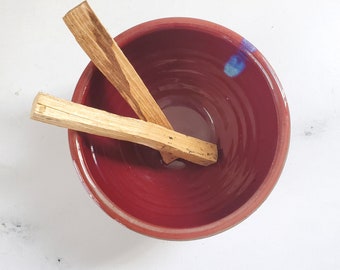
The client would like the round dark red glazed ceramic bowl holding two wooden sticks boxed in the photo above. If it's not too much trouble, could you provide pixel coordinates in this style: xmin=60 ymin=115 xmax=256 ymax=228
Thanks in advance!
xmin=69 ymin=18 xmax=290 ymax=240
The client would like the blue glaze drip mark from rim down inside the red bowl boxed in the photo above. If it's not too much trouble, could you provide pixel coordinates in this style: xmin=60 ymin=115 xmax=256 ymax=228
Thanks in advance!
xmin=224 ymin=39 xmax=256 ymax=78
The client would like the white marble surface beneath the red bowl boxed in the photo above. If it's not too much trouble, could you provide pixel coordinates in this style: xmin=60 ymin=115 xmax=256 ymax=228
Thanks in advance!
xmin=0 ymin=0 xmax=340 ymax=270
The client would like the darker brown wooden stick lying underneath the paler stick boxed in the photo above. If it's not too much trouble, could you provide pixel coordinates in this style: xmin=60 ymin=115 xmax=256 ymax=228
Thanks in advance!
xmin=64 ymin=1 xmax=176 ymax=163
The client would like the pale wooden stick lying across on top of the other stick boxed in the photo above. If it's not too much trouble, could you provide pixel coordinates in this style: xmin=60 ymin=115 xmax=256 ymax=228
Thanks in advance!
xmin=31 ymin=93 xmax=217 ymax=166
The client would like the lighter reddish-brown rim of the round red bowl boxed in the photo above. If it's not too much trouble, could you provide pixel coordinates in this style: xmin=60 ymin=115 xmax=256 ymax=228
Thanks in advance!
xmin=68 ymin=17 xmax=290 ymax=240
